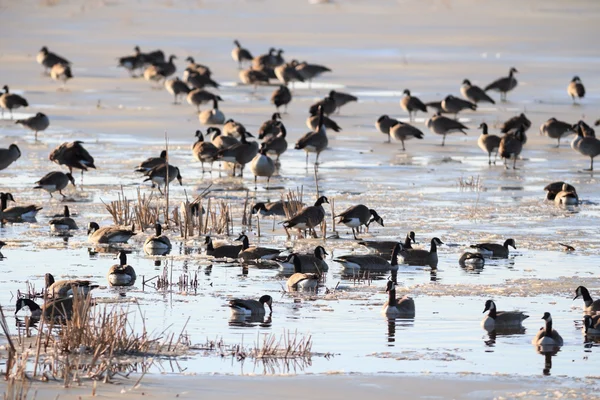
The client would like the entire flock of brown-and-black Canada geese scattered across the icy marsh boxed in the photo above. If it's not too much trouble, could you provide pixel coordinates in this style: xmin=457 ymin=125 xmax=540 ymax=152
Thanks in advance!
xmin=0 ymin=40 xmax=600 ymax=346
